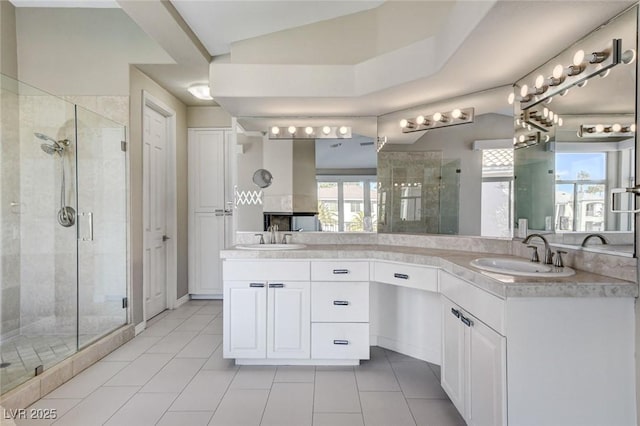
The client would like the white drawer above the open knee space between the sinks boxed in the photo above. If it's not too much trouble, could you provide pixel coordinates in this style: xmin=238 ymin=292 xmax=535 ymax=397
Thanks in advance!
xmin=373 ymin=261 xmax=438 ymax=292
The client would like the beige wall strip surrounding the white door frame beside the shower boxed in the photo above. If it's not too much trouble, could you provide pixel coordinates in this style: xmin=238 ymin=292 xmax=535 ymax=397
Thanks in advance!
xmin=129 ymin=66 xmax=188 ymax=324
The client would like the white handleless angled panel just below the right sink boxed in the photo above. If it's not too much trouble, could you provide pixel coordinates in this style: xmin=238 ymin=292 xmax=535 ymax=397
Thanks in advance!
xmin=440 ymin=271 xmax=505 ymax=336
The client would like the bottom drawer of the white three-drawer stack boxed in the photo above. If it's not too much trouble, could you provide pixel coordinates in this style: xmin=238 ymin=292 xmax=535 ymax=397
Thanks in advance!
xmin=311 ymin=323 xmax=369 ymax=359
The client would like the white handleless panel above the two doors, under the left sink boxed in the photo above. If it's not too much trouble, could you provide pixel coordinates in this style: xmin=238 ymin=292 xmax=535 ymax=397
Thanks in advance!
xmin=222 ymin=260 xmax=310 ymax=281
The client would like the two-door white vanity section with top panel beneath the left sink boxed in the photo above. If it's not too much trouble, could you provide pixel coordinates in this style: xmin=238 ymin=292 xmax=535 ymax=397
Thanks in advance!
xmin=223 ymin=261 xmax=311 ymax=363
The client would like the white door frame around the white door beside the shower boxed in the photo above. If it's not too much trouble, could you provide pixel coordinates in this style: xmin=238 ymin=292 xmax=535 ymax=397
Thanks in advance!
xmin=141 ymin=90 xmax=178 ymax=327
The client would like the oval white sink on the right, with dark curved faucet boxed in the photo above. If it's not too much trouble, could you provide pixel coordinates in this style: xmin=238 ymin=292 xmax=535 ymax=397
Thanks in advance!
xmin=470 ymin=257 xmax=576 ymax=277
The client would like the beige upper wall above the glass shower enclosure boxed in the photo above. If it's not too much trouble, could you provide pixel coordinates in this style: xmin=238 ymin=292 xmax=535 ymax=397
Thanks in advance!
xmin=16 ymin=7 xmax=173 ymax=96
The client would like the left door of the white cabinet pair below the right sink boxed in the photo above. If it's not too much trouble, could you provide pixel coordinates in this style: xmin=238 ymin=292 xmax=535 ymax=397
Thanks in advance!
xmin=440 ymin=297 xmax=466 ymax=416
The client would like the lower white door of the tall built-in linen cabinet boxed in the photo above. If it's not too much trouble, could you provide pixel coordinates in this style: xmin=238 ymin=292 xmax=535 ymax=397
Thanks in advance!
xmin=189 ymin=213 xmax=224 ymax=295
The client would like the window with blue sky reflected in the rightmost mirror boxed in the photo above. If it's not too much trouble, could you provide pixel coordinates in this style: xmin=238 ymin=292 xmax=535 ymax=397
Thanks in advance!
xmin=555 ymin=152 xmax=607 ymax=232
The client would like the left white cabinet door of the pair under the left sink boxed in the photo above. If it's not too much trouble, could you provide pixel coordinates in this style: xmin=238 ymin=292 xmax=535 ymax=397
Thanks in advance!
xmin=223 ymin=281 xmax=267 ymax=358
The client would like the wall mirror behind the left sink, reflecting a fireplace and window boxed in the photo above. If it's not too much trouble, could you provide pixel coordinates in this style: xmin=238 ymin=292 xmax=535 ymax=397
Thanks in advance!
xmin=235 ymin=117 xmax=378 ymax=232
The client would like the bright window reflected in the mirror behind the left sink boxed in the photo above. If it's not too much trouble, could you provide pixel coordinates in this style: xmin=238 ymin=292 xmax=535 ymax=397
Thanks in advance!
xmin=318 ymin=176 xmax=378 ymax=232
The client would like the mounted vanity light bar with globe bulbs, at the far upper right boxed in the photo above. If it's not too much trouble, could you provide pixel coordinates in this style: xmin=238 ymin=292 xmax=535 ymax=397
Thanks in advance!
xmin=508 ymin=38 xmax=624 ymax=110
